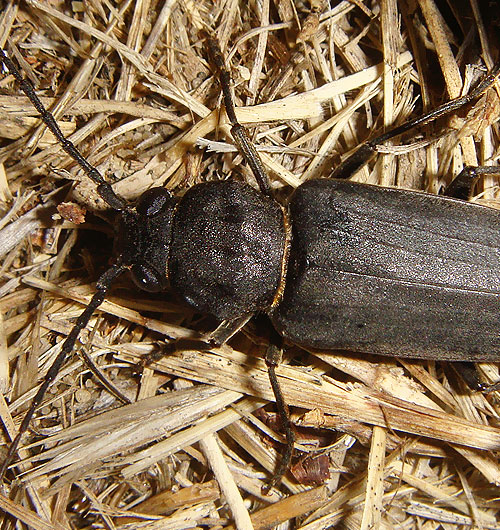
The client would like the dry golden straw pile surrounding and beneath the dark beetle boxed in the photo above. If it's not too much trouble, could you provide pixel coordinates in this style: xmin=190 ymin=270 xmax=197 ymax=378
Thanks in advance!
xmin=0 ymin=0 xmax=500 ymax=529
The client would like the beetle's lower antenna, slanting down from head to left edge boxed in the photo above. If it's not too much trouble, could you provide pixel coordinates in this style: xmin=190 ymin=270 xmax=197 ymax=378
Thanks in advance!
xmin=0 ymin=263 xmax=126 ymax=481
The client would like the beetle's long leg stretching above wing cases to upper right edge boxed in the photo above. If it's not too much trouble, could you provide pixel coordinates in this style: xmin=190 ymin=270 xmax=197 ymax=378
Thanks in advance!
xmin=330 ymin=62 xmax=500 ymax=179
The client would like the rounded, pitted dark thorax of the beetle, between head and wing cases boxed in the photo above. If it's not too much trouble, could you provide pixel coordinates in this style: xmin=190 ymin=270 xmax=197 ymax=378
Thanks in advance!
xmin=168 ymin=180 xmax=286 ymax=320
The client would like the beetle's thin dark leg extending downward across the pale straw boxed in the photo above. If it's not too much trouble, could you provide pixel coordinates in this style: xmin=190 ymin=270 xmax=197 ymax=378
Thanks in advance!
xmin=262 ymin=343 xmax=295 ymax=495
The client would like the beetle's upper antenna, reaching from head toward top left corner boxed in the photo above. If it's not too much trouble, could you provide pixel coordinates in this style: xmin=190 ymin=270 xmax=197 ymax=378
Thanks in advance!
xmin=0 ymin=48 xmax=127 ymax=211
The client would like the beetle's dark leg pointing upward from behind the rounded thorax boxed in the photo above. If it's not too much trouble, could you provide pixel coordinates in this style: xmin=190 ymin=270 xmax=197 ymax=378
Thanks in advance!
xmin=208 ymin=37 xmax=272 ymax=197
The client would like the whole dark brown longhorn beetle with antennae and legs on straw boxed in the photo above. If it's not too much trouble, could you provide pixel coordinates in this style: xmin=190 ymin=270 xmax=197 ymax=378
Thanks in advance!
xmin=0 ymin=37 xmax=500 ymax=490
